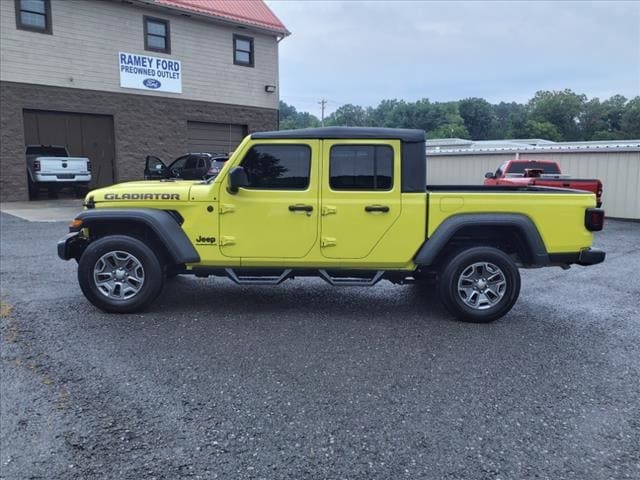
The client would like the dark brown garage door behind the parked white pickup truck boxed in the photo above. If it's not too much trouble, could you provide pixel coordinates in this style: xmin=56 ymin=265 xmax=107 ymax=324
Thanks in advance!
xmin=24 ymin=110 xmax=115 ymax=188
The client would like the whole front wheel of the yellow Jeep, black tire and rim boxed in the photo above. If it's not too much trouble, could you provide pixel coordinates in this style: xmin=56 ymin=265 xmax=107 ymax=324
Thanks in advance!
xmin=78 ymin=235 xmax=164 ymax=313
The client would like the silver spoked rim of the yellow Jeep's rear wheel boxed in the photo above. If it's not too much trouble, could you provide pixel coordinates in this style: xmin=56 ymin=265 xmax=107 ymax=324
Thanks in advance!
xmin=458 ymin=262 xmax=507 ymax=310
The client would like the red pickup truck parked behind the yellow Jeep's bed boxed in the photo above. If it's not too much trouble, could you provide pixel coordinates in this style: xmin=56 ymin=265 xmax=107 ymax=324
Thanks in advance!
xmin=484 ymin=160 xmax=602 ymax=207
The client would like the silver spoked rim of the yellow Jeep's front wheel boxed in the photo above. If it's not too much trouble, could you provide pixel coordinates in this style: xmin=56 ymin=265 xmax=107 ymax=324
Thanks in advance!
xmin=93 ymin=250 xmax=144 ymax=300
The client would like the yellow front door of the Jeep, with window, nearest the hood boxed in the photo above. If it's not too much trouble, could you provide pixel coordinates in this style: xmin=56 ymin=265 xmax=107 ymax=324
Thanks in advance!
xmin=219 ymin=140 xmax=320 ymax=256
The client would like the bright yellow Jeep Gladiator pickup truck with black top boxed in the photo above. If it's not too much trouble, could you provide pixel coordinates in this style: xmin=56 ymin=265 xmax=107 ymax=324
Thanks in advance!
xmin=58 ymin=127 xmax=605 ymax=322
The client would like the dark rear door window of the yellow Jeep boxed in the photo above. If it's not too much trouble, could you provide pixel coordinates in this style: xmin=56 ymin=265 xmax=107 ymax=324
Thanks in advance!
xmin=329 ymin=145 xmax=393 ymax=190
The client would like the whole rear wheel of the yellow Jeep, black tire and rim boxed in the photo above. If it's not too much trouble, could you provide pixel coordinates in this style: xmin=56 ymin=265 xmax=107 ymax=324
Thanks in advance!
xmin=439 ymin=247 xmax=520 ymax=323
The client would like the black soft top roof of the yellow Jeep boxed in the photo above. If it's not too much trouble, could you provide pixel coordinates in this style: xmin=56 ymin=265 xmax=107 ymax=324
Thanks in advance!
xmin=251 ymin=127 xmax=425 ymax=143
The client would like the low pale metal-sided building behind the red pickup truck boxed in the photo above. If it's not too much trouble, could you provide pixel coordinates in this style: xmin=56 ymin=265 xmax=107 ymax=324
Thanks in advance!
xmin=427 ymin=138 xmax=640 ymax=220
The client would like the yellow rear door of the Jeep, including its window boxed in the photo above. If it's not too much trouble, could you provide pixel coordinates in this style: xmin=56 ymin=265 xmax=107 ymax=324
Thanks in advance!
xmin=320 ymin=140 xmax=402 ymax=259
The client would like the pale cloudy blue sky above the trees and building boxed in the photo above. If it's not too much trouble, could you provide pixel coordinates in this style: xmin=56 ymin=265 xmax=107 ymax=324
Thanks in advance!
xmin=267 ymin=0 xmax=640 ymax=116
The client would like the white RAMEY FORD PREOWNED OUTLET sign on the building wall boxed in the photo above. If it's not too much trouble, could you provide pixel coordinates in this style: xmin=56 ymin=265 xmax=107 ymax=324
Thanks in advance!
xmin=118 ymin=52 xmax=182 ymax=93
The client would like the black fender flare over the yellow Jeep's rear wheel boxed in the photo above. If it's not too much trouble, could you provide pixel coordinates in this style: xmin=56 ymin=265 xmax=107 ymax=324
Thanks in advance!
xmin=414 ymin=213 xmax=549 ymax=266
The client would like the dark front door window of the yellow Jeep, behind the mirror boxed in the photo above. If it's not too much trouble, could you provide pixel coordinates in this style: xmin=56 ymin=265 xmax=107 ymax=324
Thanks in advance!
xmin=241 ymin=145 xmax=311 ymax=190
